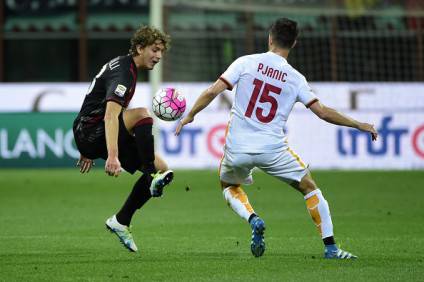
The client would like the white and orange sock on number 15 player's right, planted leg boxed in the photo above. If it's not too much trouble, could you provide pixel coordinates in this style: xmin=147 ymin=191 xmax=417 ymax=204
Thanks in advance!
xmin=304 ymin=189 xmax=333 ymax=239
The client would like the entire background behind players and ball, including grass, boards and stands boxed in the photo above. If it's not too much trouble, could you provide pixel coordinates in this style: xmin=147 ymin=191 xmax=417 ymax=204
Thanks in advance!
xmin=0 ymin=0 xmax=424 ymax=281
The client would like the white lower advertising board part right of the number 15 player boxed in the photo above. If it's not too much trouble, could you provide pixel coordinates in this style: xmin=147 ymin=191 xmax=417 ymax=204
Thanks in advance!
xmin=288 ymin=112 xmax=424 ymax=169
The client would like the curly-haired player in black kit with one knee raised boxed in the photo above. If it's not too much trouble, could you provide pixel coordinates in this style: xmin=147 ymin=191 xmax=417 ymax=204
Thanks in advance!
xmin=73 ymin=26 xmax=173 ymax=252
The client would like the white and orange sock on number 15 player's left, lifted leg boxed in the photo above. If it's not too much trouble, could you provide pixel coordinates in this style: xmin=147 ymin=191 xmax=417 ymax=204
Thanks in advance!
xmin=223 ymin=186 xmax=255 ymax=221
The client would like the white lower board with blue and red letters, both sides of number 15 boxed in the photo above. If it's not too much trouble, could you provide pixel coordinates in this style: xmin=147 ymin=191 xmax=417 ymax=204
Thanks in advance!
xmin=158 ymin=110 xmax=424 ymax=169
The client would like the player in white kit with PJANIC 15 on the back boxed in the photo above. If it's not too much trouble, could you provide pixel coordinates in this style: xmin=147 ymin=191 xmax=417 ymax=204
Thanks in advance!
xmin=175 ymin=18 xmax=377 ymax=259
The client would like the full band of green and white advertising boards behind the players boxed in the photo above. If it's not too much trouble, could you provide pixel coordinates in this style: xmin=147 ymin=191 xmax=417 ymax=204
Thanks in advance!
xmin=0 ymin=83 xmax=424 ymax=169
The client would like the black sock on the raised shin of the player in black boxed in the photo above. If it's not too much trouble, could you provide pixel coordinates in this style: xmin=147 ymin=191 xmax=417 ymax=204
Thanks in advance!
xmin=134 ymin=117 xmax=156 ymax=174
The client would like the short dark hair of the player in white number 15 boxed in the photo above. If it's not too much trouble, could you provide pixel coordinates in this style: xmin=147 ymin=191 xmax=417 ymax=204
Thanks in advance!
xmin=269 ymin=18 xmax=299 ymax=49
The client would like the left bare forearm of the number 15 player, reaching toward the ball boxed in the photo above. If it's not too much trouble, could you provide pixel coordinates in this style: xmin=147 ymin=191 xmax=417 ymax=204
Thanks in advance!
xmin=175 ymin=79 xmax=228 ymax=136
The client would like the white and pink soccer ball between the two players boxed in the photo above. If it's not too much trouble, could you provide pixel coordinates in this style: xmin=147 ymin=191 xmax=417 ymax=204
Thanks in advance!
xmin=152 ymin=88 xmax=186 ymax=121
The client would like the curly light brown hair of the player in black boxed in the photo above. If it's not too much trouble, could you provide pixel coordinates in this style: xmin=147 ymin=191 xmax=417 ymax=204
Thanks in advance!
xmin=129 ymin=25 xmax=171 ymax=56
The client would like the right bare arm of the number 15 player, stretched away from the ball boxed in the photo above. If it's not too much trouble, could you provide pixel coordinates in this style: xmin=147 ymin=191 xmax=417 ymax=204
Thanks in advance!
xmin=309 ymin=101 xmax=378 ymax=141
